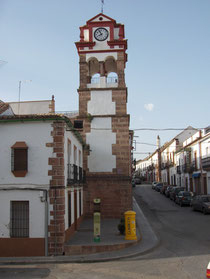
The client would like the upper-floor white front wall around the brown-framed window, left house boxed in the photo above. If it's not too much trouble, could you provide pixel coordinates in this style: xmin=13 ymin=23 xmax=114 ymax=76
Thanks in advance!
xmin=0 ymin=121 xmax=52 ymax=187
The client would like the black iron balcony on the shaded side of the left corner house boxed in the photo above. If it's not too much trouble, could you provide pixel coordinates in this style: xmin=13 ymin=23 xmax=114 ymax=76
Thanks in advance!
xmin=67 ymin=164 xmax=86 ymax=185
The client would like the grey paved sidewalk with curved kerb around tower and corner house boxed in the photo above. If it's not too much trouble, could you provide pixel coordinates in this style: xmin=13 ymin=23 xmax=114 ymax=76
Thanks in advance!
xmin=0 ymin=199 xmax=159 ymax=264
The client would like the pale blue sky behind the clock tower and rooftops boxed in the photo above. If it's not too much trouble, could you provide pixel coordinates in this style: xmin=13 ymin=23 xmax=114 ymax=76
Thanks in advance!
xmin=0 ymin=0 xmax=210 ymax=159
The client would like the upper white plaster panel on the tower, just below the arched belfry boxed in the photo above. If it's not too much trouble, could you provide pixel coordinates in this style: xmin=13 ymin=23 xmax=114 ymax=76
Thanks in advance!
xmin=87 ymin=90 xmax=116 ymax=115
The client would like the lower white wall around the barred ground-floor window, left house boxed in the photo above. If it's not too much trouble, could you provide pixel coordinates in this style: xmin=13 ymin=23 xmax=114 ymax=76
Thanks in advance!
xmin=0 ymin=190 xmax=45 ymax=238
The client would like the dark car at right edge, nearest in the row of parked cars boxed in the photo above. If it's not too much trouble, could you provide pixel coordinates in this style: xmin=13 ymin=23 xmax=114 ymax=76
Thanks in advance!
xmin=191 ymin=195 xmax=210 ymax=214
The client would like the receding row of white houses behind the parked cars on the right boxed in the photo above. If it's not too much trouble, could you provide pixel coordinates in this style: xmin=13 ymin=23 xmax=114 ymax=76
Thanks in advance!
xmin=137 ymin=127 xmax=210 ymax=194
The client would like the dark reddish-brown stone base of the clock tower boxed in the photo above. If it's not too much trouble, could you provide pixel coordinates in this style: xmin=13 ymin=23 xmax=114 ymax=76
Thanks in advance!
xmin=84 ymin=175 xmax=132 ymax=218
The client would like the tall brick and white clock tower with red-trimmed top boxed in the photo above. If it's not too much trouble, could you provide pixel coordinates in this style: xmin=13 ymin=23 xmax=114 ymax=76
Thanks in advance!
xmin=76 ymin=13 xmax=132 ymax=218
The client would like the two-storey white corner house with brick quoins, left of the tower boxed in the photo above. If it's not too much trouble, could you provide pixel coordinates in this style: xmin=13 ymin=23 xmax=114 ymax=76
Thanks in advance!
xmin=0 ymin=114 xmax=84 ymax=257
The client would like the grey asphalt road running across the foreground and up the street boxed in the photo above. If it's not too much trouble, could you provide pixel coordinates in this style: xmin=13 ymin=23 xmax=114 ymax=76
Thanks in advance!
xmin=0 ymin=185 xmax=210 ymax=279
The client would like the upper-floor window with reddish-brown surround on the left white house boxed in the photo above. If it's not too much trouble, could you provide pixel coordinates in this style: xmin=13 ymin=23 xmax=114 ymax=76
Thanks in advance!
xmin=11 ymin=141 xmax=28 ymax=177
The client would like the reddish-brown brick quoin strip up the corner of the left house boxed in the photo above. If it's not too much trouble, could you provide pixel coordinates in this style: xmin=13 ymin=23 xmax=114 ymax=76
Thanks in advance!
xmin=46 ymin=121 xmax=66 ymax=255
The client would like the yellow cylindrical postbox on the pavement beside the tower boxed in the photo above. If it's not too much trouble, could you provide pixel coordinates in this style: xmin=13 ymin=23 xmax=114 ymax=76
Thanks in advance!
xmin=124 ymin=211 xmax=137 ymax=240
